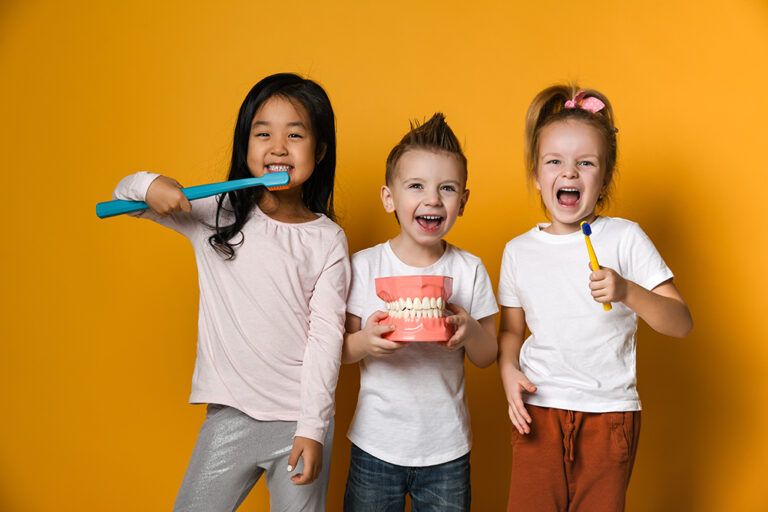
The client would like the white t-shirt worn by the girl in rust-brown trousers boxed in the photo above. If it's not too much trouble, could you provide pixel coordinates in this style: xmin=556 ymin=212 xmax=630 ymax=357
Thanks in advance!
xmin=499 ymin=217 xmax=672 ymax=412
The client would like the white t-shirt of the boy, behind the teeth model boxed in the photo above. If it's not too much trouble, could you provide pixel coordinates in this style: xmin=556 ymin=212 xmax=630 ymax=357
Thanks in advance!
xmin=347 ymin=242 xmax=498 ymax=466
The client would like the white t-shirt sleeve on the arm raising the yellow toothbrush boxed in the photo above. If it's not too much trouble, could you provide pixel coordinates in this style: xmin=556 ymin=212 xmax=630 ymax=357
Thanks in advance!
xmin=622 ymin=223 xmax=673 ymax=290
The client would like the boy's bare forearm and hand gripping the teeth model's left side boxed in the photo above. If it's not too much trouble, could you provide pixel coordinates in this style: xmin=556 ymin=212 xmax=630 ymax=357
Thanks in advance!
xmin=341 ymin=311 xmax=405 ymax=364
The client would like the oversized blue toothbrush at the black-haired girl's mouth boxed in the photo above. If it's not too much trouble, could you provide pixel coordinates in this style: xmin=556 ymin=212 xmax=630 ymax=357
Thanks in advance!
xmin=96 ymin=172 xmax=289 ymax=219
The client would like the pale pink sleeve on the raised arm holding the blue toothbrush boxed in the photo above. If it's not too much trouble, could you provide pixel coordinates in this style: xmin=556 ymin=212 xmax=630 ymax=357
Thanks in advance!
xmin=112 ymin=171 xmax=202 ymax=237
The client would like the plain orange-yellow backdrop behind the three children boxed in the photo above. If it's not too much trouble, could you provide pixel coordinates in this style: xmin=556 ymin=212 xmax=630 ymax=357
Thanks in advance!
xmin=0 ymin=0 xmax=768 ymax=512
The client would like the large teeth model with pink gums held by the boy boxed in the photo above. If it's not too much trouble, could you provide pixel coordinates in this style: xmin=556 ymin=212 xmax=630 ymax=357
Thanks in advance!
xmin=376 ymin=276 xmax=454 ymax=341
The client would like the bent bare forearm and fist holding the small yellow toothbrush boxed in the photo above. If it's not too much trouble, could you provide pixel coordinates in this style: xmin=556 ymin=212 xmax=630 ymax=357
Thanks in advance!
xmin=589 ymin=268 xmax=693 ymax=338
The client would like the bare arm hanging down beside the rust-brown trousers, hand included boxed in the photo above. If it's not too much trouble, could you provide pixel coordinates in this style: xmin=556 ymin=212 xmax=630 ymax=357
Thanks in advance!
xmin=498 ymin=307 xmax=536 ymax=434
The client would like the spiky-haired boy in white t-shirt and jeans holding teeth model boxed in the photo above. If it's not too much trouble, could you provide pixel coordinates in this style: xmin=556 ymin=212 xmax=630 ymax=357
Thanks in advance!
xmin=343 ymin=114 xmax=498 ymax=512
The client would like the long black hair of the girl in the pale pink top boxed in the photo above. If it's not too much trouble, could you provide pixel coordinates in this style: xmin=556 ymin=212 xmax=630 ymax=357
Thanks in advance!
xmin=208 ymin=73 xmax=336 ymax=259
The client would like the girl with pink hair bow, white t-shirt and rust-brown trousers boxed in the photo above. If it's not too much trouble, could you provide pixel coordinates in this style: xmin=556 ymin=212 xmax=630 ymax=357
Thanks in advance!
xmin=499 ymin=86 xmax=692 ymax=512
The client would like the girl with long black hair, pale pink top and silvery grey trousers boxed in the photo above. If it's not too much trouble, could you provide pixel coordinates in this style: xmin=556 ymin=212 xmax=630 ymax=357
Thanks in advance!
xmin=106 ymin=74 xmax=349 ymax=512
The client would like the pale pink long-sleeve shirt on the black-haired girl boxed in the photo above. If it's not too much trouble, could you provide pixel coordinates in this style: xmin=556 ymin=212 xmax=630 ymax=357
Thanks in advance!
xmin=114 ymin=172 xmax=350 ymax=443
